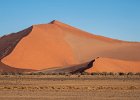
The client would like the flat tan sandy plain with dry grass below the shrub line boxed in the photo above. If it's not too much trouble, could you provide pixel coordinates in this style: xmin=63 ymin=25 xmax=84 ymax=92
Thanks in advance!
xmin=0 ymin=75 xmax=140 ymax=100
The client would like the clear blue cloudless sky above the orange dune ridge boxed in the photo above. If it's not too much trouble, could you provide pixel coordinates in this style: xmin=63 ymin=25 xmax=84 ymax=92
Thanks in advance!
xmin=0 ymin=0 xmax=140 ymax=41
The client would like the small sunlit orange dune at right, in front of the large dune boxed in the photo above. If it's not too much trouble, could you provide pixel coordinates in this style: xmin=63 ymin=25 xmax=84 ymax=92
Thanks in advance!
xmin=86 ymin=58 xmax=140 ymax=73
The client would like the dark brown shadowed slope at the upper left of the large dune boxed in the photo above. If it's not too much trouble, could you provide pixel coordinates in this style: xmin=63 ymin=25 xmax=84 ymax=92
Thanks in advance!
xmin=0 ymin=26 xmax=32 ymax=59
